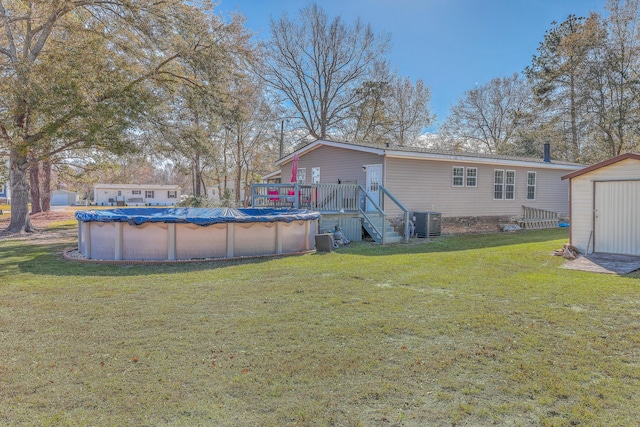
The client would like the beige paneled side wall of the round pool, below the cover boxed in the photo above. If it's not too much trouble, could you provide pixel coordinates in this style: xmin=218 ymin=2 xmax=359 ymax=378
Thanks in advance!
xmin=78 ymin=209 xmax=319 ymax=261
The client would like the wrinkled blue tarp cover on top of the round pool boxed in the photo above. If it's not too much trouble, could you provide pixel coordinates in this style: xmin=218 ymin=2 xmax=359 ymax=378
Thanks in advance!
xmin=76 ymin=208 xmax=320 ymax=226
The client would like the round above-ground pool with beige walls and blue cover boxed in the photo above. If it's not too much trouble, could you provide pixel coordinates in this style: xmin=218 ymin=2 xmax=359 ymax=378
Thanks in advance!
xmin=76 ymin=208 xmax=320 ymax=261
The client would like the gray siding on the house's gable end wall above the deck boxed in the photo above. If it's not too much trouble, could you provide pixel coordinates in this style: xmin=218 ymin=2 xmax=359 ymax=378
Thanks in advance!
xmin=281 ymin=146 xmax=384 ymax=186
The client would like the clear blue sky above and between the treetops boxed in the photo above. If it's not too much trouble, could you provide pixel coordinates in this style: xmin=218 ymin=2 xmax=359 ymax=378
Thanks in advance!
xmin=216 ymin=0 xmax=606 ymax=131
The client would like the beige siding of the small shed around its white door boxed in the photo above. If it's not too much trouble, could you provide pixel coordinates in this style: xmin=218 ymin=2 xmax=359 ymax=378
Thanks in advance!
xmin=571 ymin=159 xmax=640 ymax=252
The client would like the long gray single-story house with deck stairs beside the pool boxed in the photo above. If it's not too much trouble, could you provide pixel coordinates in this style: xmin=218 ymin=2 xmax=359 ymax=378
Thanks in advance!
xmin=277 ymin=140 xmax=583 ymax=226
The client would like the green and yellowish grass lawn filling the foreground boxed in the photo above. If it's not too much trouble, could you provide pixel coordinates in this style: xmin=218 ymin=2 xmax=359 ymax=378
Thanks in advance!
xmin=0 ymin=224 xmax=640 ymax=426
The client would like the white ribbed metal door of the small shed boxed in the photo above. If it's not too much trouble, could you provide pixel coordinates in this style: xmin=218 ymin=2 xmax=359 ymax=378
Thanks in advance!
xmin=593 ymin=181 xmax=640 ymax=255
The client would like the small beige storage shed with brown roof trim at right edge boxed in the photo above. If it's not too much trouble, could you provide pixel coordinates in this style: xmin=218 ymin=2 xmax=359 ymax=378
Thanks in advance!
xmin=562 ymin=153 xmax=640 ymax=255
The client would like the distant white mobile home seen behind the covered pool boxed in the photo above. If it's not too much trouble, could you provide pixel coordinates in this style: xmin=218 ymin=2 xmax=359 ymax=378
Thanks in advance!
xmin=93 ymin=184 xmax=180 ymax=206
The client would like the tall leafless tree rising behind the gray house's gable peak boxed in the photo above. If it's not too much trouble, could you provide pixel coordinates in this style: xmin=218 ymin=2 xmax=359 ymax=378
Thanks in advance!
xmin=259 ymin=4 xmax=388 ymax=139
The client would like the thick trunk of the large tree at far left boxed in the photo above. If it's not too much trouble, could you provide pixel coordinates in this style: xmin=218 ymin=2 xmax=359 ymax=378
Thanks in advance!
xmin=7 ymin=150 xmax=35 ymax=233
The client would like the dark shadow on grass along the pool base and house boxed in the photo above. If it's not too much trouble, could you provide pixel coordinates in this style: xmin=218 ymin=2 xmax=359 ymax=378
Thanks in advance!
xmin=5 ymin=229 xmax=568 ymax=277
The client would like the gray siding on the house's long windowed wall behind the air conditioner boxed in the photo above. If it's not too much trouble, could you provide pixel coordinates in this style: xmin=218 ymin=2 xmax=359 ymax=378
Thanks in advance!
xmin=385 ymin=158 xmax=571 ymax=217
